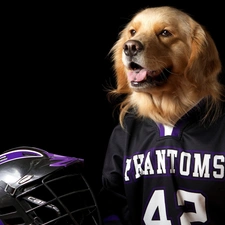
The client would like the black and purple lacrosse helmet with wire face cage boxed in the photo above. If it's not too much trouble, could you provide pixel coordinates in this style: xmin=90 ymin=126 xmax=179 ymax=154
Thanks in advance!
xmin=0 ymin=147 xmax=101 ymax=225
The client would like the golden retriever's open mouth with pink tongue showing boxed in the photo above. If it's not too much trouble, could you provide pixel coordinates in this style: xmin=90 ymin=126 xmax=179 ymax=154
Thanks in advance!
xmin=127 ymin=62 xmax=171 ymax=87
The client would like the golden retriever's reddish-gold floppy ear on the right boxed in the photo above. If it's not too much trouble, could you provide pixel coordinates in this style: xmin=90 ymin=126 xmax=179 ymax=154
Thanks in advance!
xmin=185 ymin=21 xmax=222 ymax=85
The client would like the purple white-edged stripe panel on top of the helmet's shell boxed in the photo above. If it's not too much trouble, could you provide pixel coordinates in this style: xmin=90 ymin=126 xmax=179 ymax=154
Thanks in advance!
xmin=0 ymin=150 xmax=43 ymax=165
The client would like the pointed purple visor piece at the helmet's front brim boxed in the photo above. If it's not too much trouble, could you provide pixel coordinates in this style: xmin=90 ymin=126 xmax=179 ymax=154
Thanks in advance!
xmin=45 ymin=152 xmax=84 ymax=167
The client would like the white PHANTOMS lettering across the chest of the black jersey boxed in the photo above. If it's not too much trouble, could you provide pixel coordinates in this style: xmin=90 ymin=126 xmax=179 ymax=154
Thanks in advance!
xmin=124 ymin=149 xmax=225 ymax=181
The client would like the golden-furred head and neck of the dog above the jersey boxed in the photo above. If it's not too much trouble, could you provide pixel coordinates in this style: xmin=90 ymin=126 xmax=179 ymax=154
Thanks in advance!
xmin=109 ymin=6 xmax=222 ymax=125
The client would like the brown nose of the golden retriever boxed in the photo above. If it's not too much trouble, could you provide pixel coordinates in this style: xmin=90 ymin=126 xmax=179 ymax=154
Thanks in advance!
xmin=123 ymin=40 xmax=144 ymax=57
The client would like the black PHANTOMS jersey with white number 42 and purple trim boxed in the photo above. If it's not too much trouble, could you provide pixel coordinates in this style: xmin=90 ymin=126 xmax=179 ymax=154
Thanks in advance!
xmin=100 ymin=101 xmax=225 ymax=225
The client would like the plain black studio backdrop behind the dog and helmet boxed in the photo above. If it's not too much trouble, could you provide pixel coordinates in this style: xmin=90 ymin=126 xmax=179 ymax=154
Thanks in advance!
xmin=0 ymin=0 xmax=225 ymax=195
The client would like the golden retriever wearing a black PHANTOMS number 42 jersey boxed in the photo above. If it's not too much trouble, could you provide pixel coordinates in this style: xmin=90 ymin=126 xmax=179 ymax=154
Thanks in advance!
xmin=99 ymin=6 xmax=225 ymax=225
